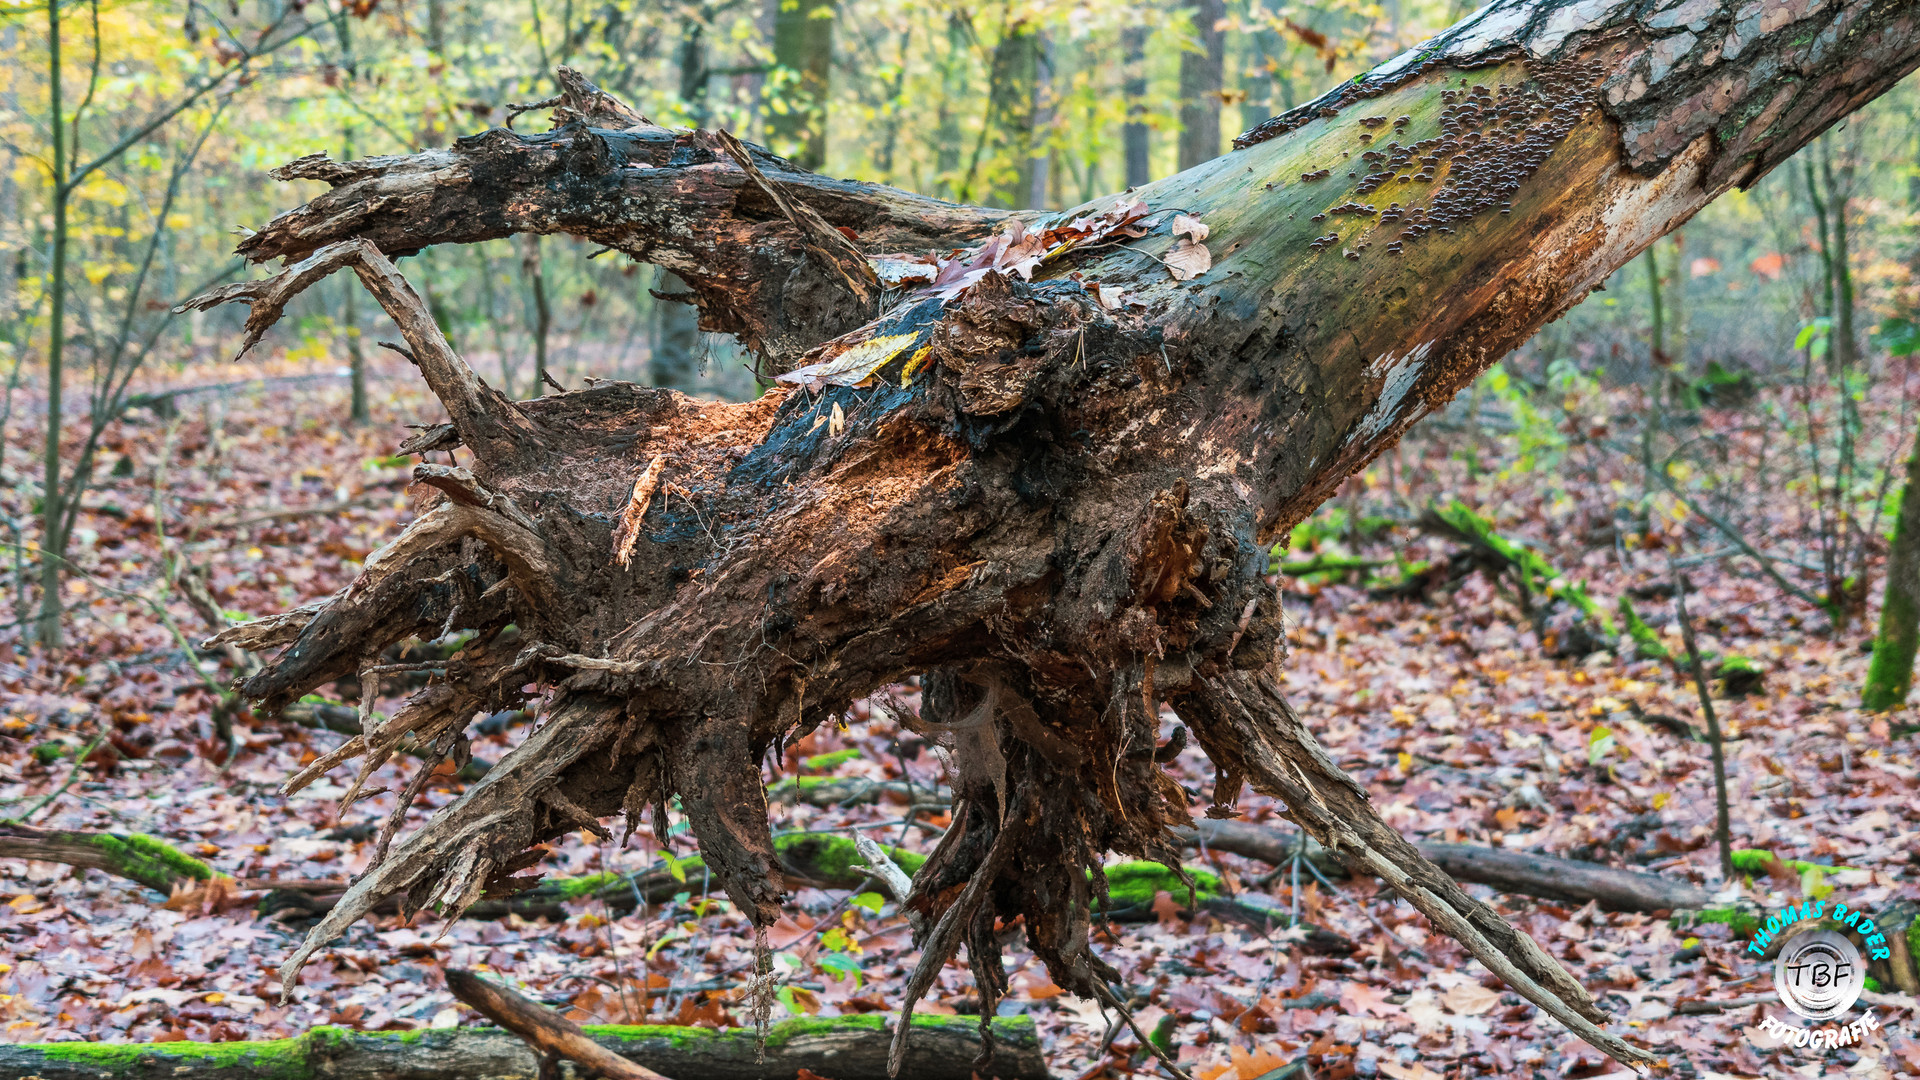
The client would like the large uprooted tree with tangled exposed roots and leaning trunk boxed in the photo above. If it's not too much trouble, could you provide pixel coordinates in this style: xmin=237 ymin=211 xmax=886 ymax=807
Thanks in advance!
xmin=191 ymin=0 xmax=1920 ymax=1061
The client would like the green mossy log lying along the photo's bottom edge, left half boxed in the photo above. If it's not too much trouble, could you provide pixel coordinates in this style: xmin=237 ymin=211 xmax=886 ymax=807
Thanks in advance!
xmin=0 ymin=1013 xmax=1048 ymax=1080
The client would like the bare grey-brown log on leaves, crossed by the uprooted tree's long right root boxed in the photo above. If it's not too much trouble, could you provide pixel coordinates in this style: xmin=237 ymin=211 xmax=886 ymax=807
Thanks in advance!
xmin=1181 ymin=819 xmax=1713 ymax=911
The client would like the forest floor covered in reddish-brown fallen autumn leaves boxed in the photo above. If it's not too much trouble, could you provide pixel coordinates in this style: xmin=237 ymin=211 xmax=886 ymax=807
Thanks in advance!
xmin=0 ymin=349 xmax=1920 ymax=1080
